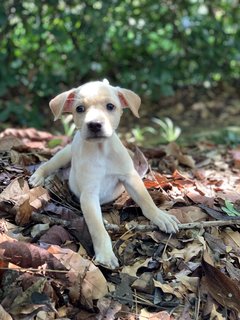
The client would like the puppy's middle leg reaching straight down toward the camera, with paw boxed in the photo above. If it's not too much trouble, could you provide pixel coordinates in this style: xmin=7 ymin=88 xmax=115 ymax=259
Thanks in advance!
xmin=80 ymin=192 xmax=119 ymax=269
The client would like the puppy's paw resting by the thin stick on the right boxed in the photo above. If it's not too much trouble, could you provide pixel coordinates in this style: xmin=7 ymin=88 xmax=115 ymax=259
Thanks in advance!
xmin=152 ymin=209 xmax=180 ymax=233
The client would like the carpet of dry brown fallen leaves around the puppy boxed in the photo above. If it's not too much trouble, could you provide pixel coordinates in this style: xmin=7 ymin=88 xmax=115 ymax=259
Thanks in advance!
xmin=0 ymin=129 xmax=240 ymax=320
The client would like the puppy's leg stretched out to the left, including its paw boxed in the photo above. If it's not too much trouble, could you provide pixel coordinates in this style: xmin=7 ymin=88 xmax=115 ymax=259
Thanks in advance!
xmin=29 ymin=144 xmax=71 ymax=187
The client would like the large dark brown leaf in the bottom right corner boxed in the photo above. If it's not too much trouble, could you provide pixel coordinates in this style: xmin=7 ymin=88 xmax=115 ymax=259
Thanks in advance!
xmin=202 ymin=259 xmax=240 ymax=312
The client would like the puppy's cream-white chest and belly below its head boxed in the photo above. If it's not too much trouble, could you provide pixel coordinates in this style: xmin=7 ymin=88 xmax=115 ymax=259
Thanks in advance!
xmin=69 ymin=132 xmax=123 ymax=203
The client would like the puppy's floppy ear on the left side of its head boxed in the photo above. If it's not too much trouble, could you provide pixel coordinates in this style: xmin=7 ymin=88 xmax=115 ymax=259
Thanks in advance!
xmin=49 ymin=88 xmax=76 ymax=121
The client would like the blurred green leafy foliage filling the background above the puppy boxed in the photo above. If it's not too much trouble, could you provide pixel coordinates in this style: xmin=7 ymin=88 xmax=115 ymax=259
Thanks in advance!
xmin=0 ymin=0 xmax=240 ymax=127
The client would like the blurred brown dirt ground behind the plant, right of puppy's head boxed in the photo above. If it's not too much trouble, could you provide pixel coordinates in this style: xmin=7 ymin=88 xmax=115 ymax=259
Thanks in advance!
xmin=120 ymin=85 xmax=240 ymax=145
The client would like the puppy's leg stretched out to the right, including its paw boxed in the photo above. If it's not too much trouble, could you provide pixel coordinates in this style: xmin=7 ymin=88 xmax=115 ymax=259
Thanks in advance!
xmin=122 ymin=170 xmax=179 ymax=233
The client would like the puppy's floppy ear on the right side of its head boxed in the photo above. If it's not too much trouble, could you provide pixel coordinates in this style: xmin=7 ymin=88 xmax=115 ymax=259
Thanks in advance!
xmin=117 ymin=88 xmax=141 ymax=118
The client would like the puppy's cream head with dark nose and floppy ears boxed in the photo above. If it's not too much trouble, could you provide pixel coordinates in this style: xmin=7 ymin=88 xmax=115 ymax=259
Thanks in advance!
xmin=50 ymin=80 xmax=141 ymax=140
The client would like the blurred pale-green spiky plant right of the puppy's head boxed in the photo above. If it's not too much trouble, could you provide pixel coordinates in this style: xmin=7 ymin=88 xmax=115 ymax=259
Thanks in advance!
xmin=153 ymin=118 xmax=181 ymax=142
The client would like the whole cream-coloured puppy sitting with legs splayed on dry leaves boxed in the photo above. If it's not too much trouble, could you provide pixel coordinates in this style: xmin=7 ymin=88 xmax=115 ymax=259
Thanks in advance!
xmin=30 ymin=81 xmax=179 ymax=269
